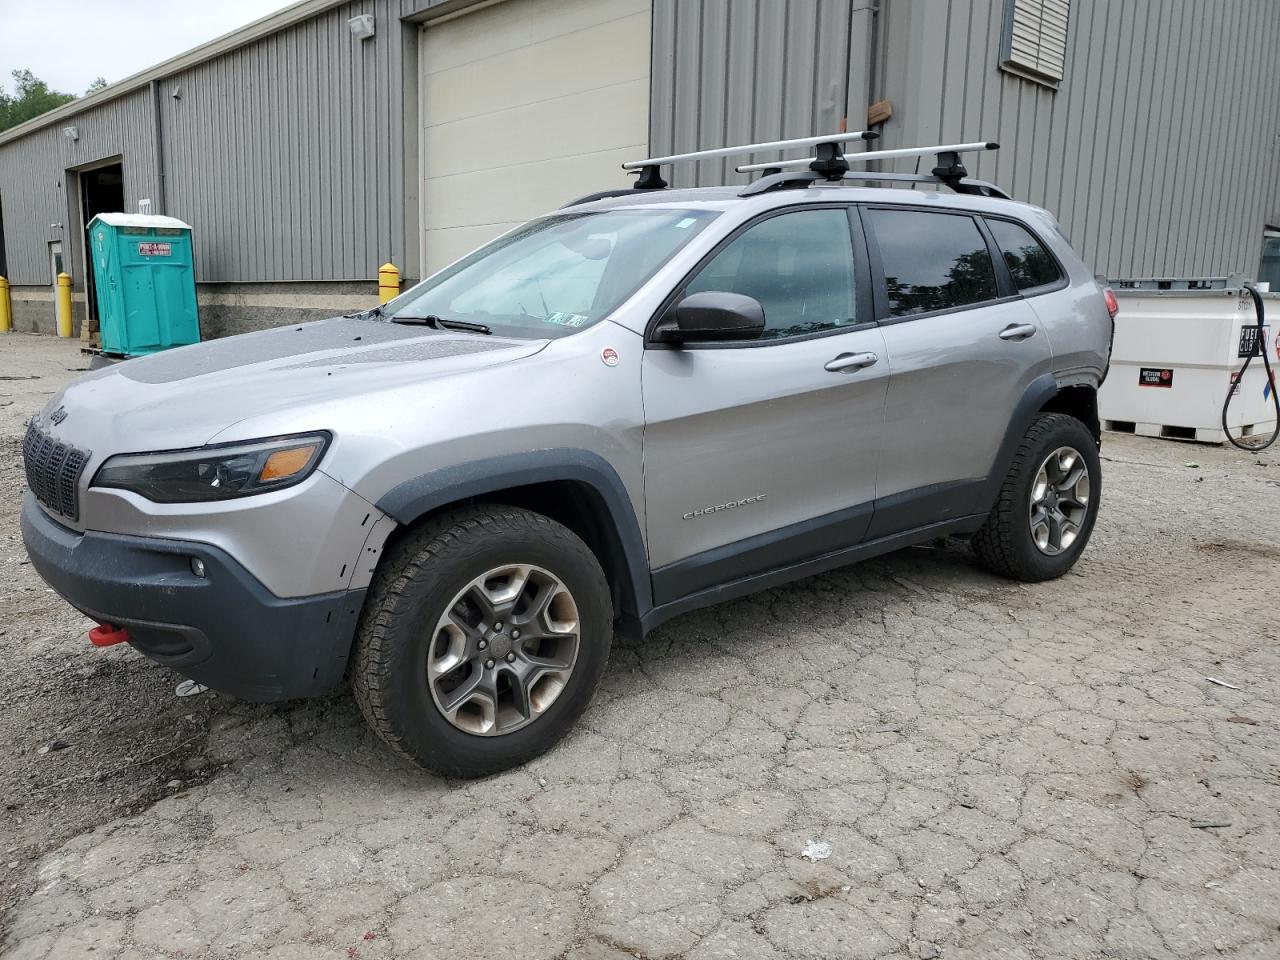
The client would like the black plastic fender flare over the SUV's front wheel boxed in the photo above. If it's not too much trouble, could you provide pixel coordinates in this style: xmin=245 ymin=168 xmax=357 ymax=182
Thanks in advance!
xmin=376 ymin=448 xmax=653 ymax=632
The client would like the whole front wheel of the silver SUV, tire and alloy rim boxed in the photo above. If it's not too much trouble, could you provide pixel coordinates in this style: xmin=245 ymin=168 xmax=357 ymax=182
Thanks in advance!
xmin=352 ymin=506 xmax=613 ymax=777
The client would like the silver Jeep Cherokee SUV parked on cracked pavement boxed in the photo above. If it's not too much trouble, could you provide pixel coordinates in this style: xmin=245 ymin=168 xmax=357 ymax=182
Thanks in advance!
xmin=22 ymin=138 xmax=1112 ymax=776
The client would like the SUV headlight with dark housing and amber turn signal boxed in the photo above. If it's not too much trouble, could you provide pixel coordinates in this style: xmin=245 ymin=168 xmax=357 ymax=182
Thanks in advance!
xmin=92 ymin=434 xmax=329 ymax=503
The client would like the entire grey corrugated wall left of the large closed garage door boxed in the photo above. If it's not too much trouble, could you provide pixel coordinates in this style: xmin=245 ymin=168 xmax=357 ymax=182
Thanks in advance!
xmin=0 ymin=0 xmax=429 ymax=285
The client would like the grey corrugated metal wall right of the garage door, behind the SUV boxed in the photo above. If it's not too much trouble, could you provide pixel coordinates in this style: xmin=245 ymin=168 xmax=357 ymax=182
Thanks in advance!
xmin=652 ymin=0 xmax=1280 ymax=276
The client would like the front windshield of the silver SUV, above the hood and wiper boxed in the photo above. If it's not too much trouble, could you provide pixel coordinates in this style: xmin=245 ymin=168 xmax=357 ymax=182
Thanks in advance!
xmin=381 ymin=210 xmax=717 ymax=338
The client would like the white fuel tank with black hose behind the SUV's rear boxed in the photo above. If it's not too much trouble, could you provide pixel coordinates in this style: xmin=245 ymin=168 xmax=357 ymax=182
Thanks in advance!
xmin=1098 ymin=276 xmax=1280 ymax=443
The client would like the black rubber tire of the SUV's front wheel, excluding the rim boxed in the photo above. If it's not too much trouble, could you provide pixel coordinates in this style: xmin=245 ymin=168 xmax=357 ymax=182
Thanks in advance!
xmin=352 ymin=506 xmax=613 ymax=777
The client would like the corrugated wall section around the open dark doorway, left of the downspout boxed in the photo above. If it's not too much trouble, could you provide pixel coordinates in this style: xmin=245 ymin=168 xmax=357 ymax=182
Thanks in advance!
xmin=0 ymin=90 xmax=156 ymax=284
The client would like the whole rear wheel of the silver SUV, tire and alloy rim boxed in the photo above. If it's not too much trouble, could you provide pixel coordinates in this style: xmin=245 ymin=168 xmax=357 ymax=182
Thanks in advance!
xmin=973 ymin=413 xmax=1102 ymax=582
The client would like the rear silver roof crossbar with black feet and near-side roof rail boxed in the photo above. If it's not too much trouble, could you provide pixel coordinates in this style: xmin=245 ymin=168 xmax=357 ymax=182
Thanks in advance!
xmin=736 ymin=141 xmax=1010 ymax=200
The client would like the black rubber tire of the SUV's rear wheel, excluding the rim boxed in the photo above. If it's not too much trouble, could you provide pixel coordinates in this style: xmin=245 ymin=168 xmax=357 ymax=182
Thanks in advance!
xmin=972 ymin=413 xmax=1102 ymax=582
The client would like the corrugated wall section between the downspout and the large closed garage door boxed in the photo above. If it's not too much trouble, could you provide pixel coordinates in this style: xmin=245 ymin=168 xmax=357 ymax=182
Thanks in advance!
xmin=160 ymin=0 xmax=416 ymax=280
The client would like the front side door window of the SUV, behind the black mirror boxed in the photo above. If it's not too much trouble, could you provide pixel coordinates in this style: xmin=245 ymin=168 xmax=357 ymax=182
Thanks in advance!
xmin=685 ymin=210 xmax=855 ymax=339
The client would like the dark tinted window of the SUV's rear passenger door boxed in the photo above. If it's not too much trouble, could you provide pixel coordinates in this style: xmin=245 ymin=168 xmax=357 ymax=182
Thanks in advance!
xmin=867 ymin=210 xmax=996 ymax=316
